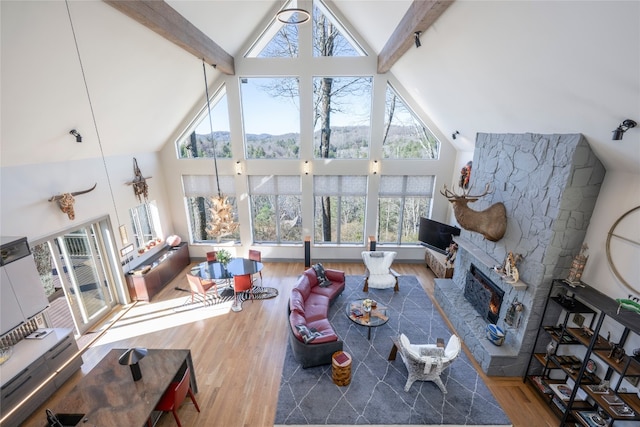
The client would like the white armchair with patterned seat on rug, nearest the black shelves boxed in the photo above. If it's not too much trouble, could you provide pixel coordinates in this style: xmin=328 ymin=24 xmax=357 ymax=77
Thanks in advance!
xmin=394 ymin=334 xmax=462 ymax=393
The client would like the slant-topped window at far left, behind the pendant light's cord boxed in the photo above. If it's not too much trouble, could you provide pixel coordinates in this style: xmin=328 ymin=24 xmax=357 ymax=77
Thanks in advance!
xmin=178 ymin=86 xmax=231 ymax=159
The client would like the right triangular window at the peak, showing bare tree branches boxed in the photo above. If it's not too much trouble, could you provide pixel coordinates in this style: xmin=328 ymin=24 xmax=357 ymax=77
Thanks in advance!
xmin=313 ymin=1 xmax=367 ymax=57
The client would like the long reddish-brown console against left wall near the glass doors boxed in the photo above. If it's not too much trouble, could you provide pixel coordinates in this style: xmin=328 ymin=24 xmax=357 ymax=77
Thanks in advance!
xmin=126 ymin=243 xmax=191 ymax=301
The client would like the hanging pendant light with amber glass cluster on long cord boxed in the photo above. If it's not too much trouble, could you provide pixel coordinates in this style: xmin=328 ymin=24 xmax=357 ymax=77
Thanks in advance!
xmin=202 ymin=60 xmax=240 ymax=241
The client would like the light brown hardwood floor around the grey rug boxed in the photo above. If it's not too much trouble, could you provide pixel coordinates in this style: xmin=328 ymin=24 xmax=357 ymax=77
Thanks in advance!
xmin=24 ymin=262 xmax=558 ymax=427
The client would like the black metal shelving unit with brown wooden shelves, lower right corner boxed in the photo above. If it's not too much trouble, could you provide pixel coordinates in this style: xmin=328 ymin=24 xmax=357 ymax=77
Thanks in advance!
xmin=523 ymin=280 xmax=640 ymax=427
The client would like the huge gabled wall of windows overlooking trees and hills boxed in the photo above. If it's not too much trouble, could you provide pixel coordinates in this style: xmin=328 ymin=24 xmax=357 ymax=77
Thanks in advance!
xmin=166 ymin=2 xmax=455 ymax=257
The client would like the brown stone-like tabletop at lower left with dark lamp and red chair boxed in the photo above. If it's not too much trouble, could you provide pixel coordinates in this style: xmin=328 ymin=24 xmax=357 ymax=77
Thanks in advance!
xmin=52 ymin=349 xmax=198 ymax=427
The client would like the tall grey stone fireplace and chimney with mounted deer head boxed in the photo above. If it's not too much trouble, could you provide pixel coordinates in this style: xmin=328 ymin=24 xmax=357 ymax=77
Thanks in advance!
xmin=434 ymin=134 xmax=605 ymax=376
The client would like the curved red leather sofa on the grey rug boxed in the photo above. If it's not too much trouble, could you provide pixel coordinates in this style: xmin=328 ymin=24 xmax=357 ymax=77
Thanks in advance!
xmin=288 ymin=268 xmax=345 ymax=368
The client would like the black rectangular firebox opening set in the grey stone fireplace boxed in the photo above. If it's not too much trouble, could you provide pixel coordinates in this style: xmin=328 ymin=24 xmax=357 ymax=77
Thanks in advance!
xmin=464 ymin=264 xmax=504 ymax=323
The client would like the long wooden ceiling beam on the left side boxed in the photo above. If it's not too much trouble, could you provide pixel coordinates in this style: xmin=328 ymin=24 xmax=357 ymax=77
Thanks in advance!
xmin=103 ymin=0 xmax=235 ymax=75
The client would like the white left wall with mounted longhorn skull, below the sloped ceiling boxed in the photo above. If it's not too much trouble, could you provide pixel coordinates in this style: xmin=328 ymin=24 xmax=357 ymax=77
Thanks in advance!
xmin=0 ymin=152 xmax=174 ymax=260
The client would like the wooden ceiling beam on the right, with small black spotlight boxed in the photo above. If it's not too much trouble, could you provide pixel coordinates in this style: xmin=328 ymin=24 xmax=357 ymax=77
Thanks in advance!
xmin=378 ymin=0 xmax=454 ymax=74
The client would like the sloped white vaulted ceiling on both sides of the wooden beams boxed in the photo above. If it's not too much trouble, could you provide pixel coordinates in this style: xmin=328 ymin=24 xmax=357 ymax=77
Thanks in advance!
xmin=0 ymin=0 xmax=640 ymax=174
